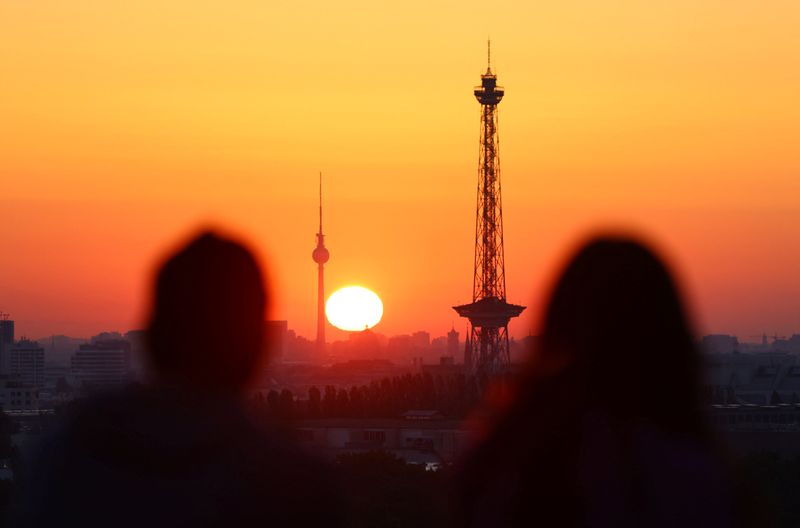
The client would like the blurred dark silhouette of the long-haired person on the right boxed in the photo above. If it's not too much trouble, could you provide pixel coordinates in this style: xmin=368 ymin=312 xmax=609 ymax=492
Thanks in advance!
xmin=459 ymin=236 xmax=748 ymax=528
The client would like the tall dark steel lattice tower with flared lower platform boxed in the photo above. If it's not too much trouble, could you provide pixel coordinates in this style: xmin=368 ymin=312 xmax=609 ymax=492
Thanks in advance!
xmin=453 ymin=42 xmax=525 ymax=384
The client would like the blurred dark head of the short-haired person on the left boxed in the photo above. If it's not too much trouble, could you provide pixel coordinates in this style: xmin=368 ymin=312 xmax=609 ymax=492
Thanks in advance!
xmin=148 ymin=232 xmax=267 ymax=392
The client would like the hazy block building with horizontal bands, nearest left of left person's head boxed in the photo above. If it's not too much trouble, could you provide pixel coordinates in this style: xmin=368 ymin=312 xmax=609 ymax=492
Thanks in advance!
xmin=71 ymin=339 xmax=131 ymax=390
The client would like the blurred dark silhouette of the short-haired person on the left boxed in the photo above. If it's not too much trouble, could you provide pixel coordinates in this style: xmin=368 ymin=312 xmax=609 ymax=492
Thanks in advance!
xmin=13 ymin=233 xmax=340 ymax=527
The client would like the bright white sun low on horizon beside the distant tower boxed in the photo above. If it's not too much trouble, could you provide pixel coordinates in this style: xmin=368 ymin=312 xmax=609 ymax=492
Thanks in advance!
xmin=325 ymin=286 xmax=383 ymax=332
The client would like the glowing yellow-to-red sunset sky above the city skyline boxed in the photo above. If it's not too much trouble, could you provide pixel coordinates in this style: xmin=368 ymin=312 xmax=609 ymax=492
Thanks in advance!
xmin=0 ymin=0 xmax=800 ymax=339
